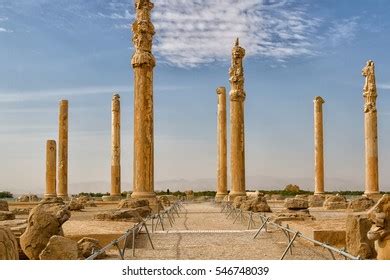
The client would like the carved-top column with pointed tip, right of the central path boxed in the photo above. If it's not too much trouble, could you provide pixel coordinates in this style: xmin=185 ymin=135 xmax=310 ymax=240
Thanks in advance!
xmin=229 ymin=39 xmax=246 ymax=198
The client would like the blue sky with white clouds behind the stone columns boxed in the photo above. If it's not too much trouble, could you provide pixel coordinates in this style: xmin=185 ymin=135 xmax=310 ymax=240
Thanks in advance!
xmin=0 ymin=0 xmax=390 ymax=192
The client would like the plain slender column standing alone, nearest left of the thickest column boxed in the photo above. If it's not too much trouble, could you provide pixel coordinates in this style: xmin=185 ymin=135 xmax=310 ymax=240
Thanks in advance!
xmin=110 ymin=94 xmax=121 ymax=199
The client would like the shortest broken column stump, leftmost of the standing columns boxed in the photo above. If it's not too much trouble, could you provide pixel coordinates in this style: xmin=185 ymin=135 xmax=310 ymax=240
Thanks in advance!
xmin=45 ymin=140 xmax=57 ymax=198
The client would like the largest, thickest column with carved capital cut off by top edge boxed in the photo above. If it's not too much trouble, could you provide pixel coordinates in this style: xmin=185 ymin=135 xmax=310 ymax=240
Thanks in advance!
xmin=131 ymin=0 xmax=156 ymax=198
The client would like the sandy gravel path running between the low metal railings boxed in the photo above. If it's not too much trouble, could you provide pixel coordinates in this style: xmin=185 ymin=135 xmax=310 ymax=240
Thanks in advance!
xmin=103 ymin=203 xmax=344 ymax=260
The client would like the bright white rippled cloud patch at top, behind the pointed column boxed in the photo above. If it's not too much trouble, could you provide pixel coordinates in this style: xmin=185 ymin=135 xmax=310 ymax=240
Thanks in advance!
xmin=148 ymin=0 xmax=320 ymax=67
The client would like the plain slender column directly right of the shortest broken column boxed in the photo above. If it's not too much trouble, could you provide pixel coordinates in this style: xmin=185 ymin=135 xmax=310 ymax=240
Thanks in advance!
xmin=58 ymin=100 xmax=68 ymax=199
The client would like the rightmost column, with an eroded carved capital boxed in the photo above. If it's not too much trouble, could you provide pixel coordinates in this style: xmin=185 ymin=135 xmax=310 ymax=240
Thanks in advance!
xmin=362 ymin=60 xmax=379 ymax=195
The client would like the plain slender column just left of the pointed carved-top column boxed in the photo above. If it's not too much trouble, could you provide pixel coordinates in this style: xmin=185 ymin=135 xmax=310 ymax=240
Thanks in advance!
xmin=215 ymin=87 xmax=228 ymax=201
